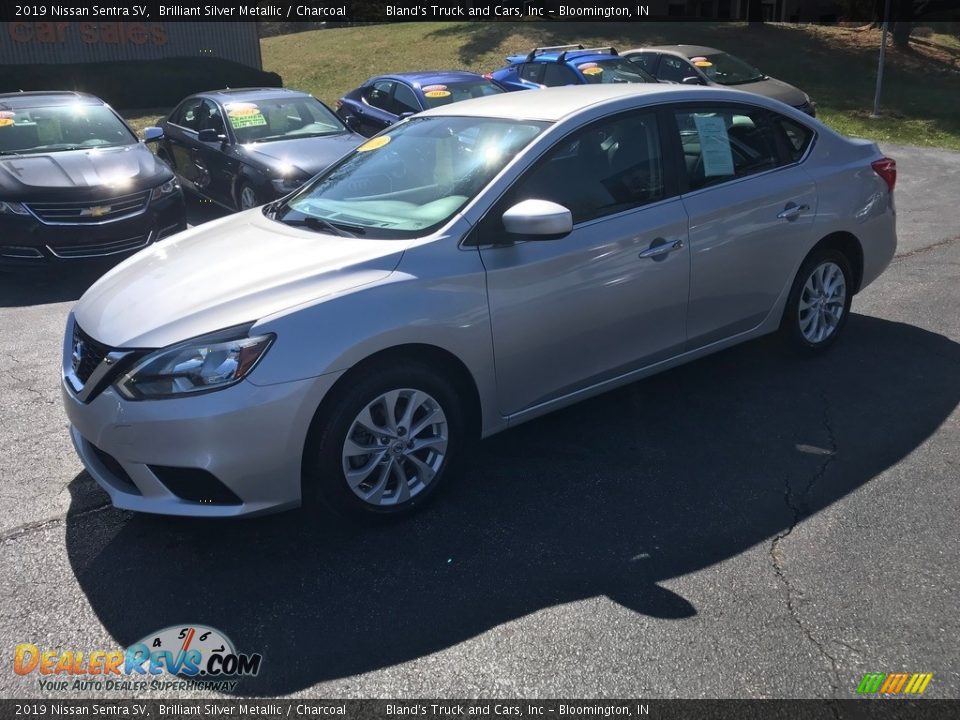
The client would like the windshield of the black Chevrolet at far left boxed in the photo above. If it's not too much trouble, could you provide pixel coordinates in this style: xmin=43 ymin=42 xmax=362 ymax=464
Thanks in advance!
xmin=0 ymin=103 xmax=137 ymax=155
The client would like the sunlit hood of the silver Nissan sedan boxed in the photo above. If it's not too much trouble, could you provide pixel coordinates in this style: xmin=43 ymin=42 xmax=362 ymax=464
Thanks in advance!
xmin=74 ymin=208 xmax=406 ymax=348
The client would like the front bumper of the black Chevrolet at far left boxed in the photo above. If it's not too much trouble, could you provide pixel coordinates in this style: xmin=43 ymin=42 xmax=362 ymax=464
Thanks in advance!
xmin=0 ymin=192 xmax=187 ymax=267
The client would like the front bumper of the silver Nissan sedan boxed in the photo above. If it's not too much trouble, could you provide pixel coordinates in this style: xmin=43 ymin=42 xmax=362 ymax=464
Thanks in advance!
xmin=63 ymin=366 xmax=339 ymax=517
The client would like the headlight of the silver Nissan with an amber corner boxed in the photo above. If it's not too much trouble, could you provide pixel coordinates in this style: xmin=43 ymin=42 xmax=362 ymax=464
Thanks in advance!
xmin=117 ymin=325 xmax=275 ymax=400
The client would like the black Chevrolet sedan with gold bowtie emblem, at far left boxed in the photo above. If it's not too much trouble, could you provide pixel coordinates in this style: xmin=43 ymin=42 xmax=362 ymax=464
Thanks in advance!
xmin=0 ymin=92 xmax=186 ymax=268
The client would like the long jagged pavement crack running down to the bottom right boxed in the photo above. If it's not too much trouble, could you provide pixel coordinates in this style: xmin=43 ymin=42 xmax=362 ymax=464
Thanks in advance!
xmin=770 ymin=391 xmax=840 ymax=696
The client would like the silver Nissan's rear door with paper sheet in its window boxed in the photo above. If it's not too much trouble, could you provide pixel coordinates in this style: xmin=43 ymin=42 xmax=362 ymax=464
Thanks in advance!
xmin=664 ymin=102 xmax=817 ymax=348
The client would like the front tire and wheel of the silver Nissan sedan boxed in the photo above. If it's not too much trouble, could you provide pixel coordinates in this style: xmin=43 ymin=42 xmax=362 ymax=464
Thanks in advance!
xmin=303 ymin=361 xmax=464 ymax=518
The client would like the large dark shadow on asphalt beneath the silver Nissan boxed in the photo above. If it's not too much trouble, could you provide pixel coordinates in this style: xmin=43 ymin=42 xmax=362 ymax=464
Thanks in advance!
xmin=66 ymin=315 xmax=960 ymax=696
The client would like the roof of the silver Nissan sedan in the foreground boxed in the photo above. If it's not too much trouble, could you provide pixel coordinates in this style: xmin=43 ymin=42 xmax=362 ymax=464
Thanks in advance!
xmin=418 ymin=83 xmax=767 ymax=122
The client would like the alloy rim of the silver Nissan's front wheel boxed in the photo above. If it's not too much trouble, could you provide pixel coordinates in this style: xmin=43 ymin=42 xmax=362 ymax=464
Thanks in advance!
xmin=341 ymin=388 xmax=447 ymax=506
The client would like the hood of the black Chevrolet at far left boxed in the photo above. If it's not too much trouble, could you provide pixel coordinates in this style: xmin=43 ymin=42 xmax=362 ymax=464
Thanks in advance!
xmin=0 ymin=143 xmax=173 ymax=201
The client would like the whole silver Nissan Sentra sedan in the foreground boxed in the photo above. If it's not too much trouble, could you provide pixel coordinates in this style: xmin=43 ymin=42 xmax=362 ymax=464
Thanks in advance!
xmin=63 ymin=84 xmax=896 ymax=516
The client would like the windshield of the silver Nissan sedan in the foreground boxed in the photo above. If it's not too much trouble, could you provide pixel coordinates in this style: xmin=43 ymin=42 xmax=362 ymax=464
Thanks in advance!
xmin=274 ymin=116 xmax=548 ymax=239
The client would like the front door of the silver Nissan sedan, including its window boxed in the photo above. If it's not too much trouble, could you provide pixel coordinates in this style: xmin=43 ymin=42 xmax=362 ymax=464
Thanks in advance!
xmin=478 ymin=104 xmax=690 ymax=415
